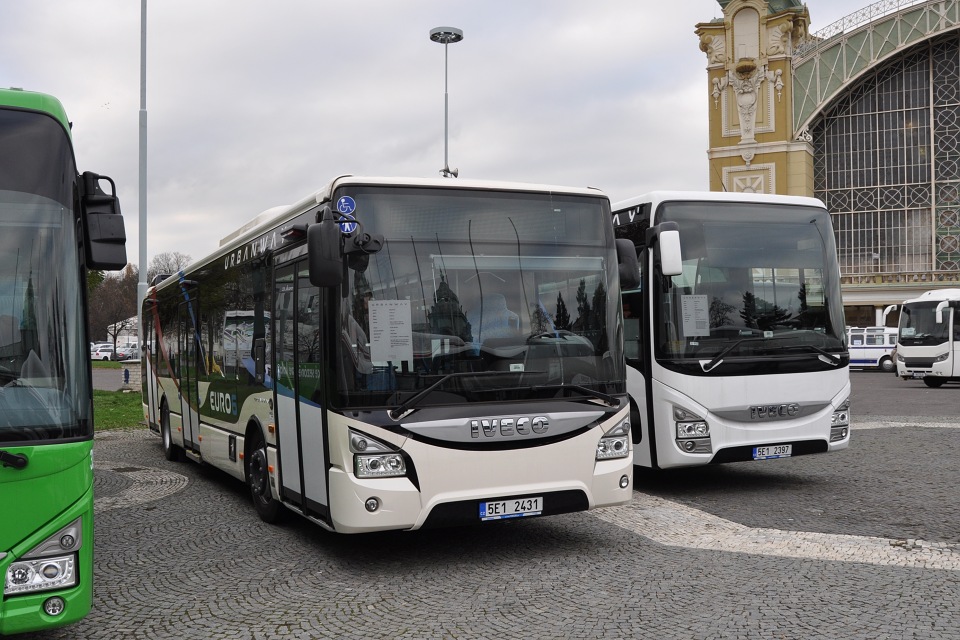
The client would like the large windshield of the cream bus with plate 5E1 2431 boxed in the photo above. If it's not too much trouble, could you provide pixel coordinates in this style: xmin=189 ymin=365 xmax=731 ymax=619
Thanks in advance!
xmin=338 ymin=187 xmax=624 ymax=406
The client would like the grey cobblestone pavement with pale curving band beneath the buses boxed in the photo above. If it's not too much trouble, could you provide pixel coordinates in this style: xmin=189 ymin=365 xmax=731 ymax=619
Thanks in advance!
xmin=20 ymin=420 xmax=960 ymax=640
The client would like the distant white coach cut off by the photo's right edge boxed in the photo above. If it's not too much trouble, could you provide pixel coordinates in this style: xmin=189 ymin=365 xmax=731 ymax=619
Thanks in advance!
xmin=884 ymin=289 xmax=960 ymax=387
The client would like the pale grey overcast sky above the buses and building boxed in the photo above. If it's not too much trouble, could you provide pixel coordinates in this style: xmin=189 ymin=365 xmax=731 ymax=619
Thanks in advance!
xmin=0 ymin=0 xmax=870 ymax=264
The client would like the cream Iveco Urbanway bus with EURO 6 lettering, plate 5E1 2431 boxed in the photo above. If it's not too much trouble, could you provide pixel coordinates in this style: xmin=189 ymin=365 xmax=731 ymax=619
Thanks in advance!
xmin=143 ymin=177 xmax=637 ymax=533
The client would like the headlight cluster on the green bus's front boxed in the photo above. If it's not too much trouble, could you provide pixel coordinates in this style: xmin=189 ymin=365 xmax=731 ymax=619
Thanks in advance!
xmin=3 ymin=518 xmax=83 ymax=595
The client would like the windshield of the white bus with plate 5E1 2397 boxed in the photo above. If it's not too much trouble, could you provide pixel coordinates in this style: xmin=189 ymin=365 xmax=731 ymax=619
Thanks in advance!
xmin=652 ymin=202 xmax=845 ymax=371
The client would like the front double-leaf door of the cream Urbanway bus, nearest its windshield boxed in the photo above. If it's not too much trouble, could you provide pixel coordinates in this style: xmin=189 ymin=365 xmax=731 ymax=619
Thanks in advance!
xmin=274 ymin=260 xmax=329 ymax=518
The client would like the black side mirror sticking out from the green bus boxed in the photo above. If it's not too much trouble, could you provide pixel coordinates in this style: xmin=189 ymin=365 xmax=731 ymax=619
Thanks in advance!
xmin=80 ymin=171 xmax=127 ymax=271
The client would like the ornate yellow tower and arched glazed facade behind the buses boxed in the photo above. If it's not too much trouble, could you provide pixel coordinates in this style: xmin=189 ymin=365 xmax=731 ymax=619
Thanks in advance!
xmin=696 ymin=0 xmax=960 ymax=326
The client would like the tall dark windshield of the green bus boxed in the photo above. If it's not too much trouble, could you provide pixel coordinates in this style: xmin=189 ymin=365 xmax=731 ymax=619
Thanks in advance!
xmin=0 ymin=111 xmax=93 ymax=442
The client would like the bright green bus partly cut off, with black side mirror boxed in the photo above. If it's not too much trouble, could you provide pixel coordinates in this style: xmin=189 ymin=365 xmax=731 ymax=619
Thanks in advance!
xmin=0 ymin=89 xmax=127 ymax=635
